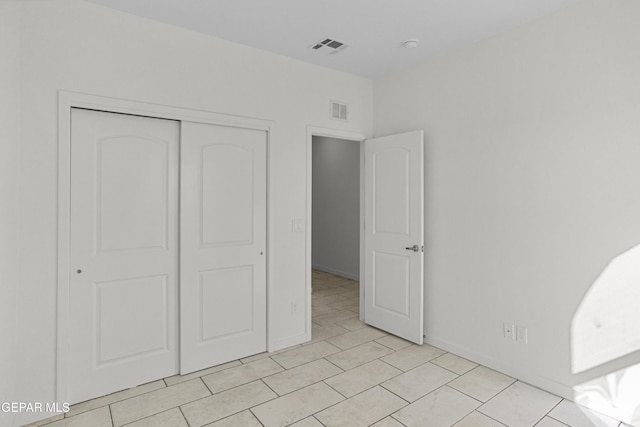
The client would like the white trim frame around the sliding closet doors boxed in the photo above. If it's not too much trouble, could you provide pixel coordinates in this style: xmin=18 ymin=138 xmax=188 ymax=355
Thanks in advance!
xmin=56 ymin=90 xmax=277 ymax=402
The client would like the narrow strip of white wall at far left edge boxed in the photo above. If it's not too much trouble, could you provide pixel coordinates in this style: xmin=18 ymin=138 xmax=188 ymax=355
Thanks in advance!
xmin=0 ymin=1 xmax=21 ymax=422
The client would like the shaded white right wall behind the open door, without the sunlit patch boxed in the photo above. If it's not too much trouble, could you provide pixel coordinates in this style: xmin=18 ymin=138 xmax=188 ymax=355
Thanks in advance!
xmin=374 ymin=0 xmax=640 ymax=397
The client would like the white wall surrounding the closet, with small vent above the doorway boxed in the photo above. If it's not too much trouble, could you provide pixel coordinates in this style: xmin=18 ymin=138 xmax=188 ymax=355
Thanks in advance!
xmin=5 ymin=0 xmax=372 ymax=422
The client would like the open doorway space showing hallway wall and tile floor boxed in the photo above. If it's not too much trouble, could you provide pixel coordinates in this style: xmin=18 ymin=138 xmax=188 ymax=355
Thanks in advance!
xmin=310 ymin=135 xmax=362 ymax=332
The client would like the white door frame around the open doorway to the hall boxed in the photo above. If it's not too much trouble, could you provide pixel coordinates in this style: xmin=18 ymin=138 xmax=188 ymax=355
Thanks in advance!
xmin=305 ymin=125 xmax=366 ymax=332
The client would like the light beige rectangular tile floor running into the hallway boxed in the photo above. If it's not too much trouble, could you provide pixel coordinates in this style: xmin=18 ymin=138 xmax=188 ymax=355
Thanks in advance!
xmin=31 ymin=271 xmax=624 ymax=427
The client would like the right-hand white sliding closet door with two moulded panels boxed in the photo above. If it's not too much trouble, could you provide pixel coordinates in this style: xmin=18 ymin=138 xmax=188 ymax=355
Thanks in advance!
xmin=180 ymin=122 xmax=267 ymax=374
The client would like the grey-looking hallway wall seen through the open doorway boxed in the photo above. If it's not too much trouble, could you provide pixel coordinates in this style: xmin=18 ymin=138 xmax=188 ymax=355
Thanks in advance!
xmin=311 ymin=136 xmax=360 ymax=280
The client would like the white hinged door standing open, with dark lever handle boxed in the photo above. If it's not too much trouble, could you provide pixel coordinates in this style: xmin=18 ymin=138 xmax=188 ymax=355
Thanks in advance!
xmin=364 ymin=131 xmax=424 ymax=344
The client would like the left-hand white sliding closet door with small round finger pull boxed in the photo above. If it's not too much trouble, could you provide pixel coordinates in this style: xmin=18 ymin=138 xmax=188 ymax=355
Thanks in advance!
xmin=68 ymin=109 xmax=179 ymax=403
